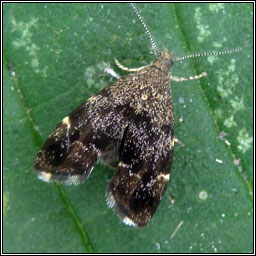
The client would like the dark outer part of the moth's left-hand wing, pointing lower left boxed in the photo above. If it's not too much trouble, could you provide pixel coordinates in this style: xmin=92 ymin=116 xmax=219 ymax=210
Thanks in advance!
xmin=34 ymin=88 xmax=130 ymax=184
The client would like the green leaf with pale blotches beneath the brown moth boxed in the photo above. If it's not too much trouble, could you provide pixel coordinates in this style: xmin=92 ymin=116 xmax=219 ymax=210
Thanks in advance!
xmin=3 ymin=3 xmax=253 ymax=253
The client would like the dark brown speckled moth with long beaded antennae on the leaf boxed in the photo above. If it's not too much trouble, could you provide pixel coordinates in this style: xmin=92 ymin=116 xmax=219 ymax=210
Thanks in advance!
xmin=34 ymin=4 xmax=242 ymax=227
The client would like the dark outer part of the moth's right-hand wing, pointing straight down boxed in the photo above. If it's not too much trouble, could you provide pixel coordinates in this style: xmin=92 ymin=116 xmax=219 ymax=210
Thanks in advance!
xmin=106 ymin=111 xmax=174 ymax=226
